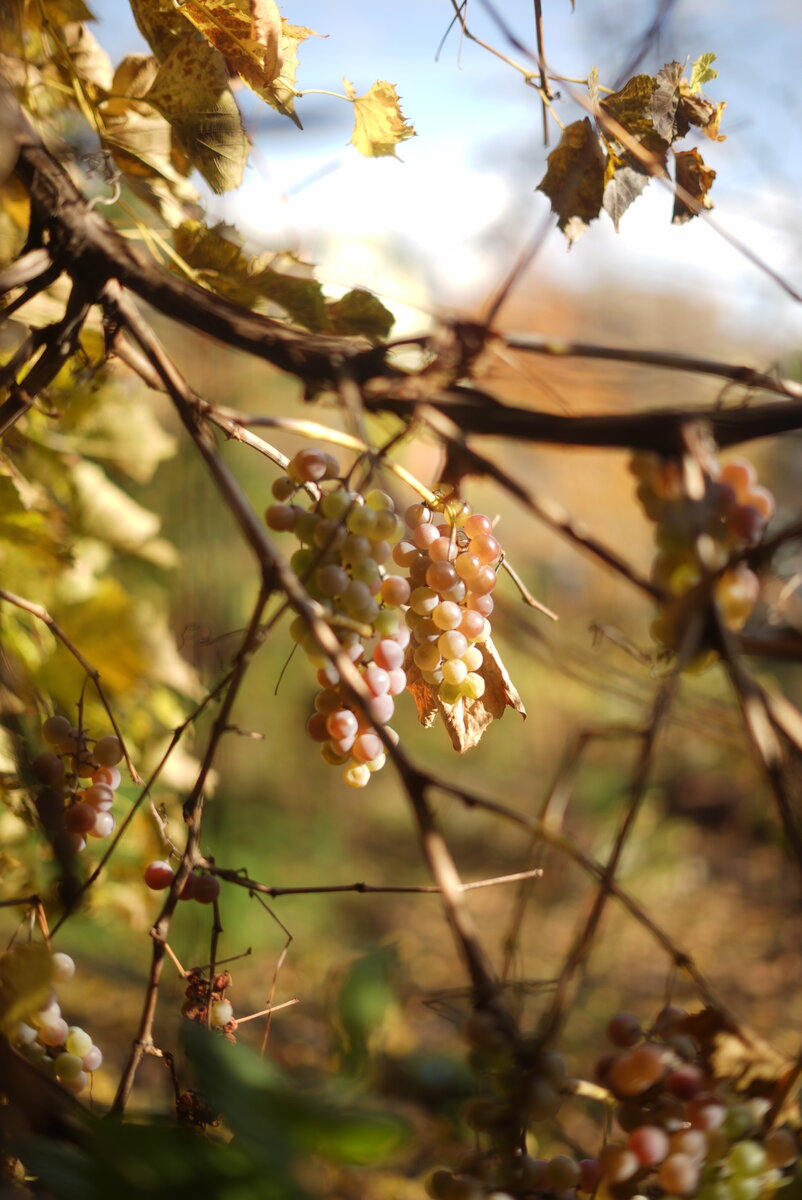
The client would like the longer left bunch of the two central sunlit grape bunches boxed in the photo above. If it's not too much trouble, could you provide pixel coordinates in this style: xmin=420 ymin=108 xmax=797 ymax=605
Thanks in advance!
xmin=265 ymin=449 xmax=411 ymax=787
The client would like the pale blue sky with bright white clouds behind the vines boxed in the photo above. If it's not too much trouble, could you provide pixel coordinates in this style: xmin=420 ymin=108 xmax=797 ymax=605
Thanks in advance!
xmin=94 ymin=0 xmax=802 ymax=344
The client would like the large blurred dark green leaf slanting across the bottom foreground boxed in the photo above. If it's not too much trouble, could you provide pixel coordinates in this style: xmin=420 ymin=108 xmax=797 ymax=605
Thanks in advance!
xmin=185 ymin=1022 xmax=408 ymax=1164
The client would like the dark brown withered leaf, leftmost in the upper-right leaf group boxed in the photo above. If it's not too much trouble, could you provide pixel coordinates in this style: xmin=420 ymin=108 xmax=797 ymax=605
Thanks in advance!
xmin=537 ymin=116 xmax=604 ymax=244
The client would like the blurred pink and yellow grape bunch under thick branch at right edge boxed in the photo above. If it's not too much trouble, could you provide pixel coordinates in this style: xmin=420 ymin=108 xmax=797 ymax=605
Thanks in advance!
xmin=630 ymin=454 xmax=774 ymax=650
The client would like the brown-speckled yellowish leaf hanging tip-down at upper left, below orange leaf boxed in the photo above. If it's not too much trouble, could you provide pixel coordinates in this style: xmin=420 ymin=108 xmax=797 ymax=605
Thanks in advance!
xmin=146 ymin=32 xmax=249 ymax=192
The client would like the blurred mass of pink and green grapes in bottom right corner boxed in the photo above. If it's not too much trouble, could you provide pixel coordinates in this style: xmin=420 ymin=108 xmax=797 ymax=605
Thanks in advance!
xmin=426 ymin=1006 xmax=801 ymax=1200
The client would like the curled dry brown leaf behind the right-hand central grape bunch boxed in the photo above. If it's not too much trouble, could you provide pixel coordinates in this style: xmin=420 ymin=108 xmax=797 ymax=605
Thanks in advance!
xmin=407 ymin=638 xmax=526 ymax=754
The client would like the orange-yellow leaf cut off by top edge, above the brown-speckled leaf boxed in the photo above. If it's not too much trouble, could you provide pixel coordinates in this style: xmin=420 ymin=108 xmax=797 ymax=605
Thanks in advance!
xmin=181 ymin=0 xmax=283 ymax=95
